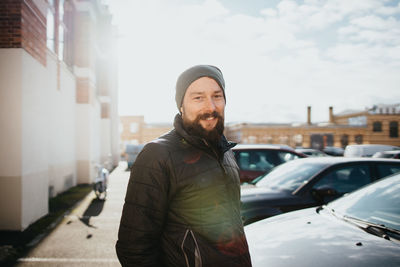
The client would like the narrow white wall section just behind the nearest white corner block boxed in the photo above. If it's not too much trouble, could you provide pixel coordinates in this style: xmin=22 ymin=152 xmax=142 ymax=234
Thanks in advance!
xmin=47 ymin=56 xmax=77 ymax=197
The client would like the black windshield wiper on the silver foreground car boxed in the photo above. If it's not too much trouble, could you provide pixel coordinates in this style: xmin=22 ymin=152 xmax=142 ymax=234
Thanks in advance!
xmin=343 ymin=215 xmax=400 ymax=240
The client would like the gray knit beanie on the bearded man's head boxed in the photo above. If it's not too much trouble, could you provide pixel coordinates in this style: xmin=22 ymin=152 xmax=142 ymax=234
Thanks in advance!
xmin=175 ymin=65 xmax=226 ymax=111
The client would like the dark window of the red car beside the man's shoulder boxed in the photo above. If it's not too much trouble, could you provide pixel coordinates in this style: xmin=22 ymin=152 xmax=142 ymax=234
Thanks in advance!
xmin=235 ymin=150 xmax=282 ymax=172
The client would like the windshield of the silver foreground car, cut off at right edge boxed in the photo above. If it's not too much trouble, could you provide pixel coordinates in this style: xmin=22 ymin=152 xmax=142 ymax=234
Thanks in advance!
xmin=328 ymin=174 xmax=400 ymax=231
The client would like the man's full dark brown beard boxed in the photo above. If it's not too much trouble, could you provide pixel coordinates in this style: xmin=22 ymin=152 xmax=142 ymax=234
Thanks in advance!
xmin=182 ymin=111 xmax=224 ymax=146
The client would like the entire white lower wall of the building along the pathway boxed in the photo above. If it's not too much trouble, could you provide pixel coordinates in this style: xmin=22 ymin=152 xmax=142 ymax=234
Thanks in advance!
xmin=0 ymin=0 xmax=119 ymax=230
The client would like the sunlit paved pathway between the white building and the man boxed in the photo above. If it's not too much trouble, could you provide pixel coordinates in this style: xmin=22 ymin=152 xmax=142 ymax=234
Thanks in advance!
xmin=16 ymin=162 xmax=129 ymax=266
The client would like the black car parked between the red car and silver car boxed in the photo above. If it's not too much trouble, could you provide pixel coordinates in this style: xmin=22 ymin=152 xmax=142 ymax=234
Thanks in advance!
xmin=241 ymin=157 xmax=400 ymax=225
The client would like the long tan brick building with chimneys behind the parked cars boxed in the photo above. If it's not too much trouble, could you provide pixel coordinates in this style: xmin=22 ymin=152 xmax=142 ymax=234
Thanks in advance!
xmin=225 ymin=104 xmax=400 ymax=149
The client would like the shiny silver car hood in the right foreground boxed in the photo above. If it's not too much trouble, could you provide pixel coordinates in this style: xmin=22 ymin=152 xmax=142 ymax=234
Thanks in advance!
xmin=245 ymin=208 xmax=400 ymax=267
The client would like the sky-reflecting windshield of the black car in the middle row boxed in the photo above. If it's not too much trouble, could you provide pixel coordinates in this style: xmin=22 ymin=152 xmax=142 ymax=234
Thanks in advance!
xmin=256 ymin=160 xmax=326 ymax=192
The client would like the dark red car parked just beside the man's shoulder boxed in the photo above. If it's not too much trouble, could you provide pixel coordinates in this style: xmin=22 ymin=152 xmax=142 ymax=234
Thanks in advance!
xmin=232 ymin=144 xmax=307 ymax=183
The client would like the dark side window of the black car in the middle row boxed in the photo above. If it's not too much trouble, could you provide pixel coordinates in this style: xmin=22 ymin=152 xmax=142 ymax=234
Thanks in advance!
xmin=314 ymin=164 xmax=371 ymax=194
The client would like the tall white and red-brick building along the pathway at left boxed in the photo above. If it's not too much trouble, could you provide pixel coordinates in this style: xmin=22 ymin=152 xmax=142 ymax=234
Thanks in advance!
xmin=0 ymin=0 xmax=119 ymax=230
